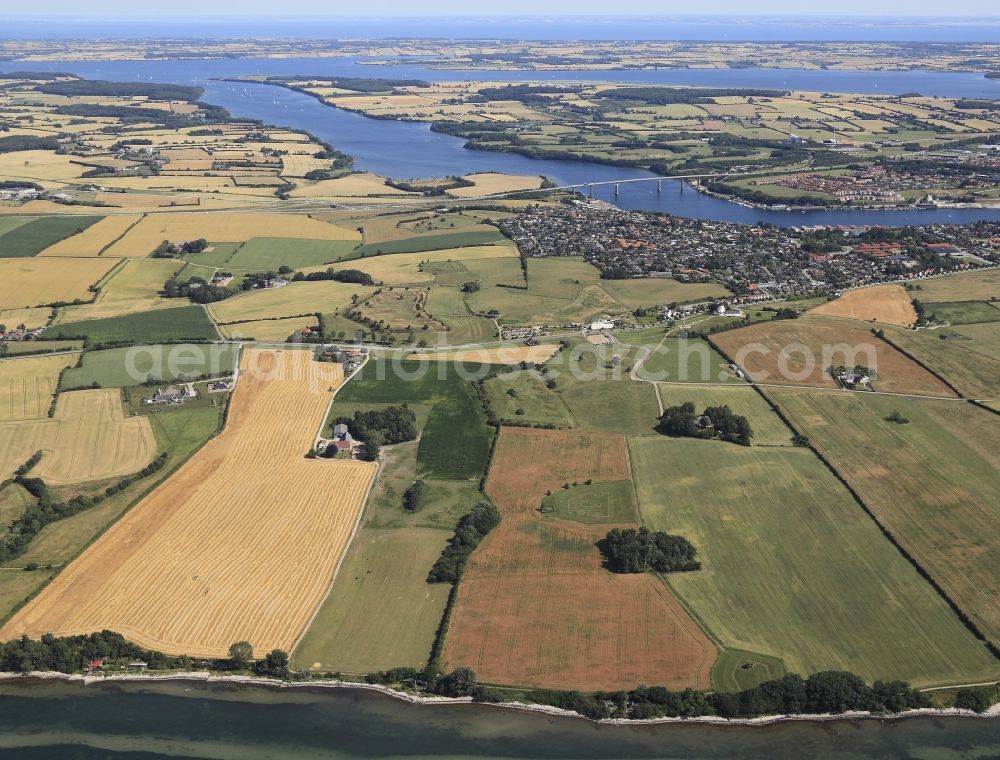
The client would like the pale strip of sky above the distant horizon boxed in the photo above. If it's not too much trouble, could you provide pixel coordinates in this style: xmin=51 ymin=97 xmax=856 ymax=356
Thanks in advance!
xmin=0 ymin=0 xmax=1000 ymax=20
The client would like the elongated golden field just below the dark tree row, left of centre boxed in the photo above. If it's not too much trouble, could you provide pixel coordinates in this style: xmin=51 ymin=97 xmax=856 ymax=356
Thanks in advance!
xmin=208 ymin=280 xmax=375 ymax=322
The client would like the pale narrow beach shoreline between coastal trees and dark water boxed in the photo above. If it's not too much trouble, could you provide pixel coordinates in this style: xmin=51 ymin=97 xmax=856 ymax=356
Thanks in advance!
xmin=0 ymin=670 xmax=1000 ymax=727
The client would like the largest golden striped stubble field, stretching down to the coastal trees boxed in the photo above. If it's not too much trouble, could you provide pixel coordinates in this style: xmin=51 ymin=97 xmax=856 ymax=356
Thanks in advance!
xmin=0 ymin=350 xmax=376 ymax=657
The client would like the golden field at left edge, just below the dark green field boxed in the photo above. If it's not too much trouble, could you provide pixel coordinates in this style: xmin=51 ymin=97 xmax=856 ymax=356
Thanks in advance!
xmin=0 ymin=256 xmax=117 ymax=309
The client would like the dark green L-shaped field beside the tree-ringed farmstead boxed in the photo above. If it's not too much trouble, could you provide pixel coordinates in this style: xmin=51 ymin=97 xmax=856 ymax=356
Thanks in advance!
xmin=337 ymin=355 xmax=493 ymax=480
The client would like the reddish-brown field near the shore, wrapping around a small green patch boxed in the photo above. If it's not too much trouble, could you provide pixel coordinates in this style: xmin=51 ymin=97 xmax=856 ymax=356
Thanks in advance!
xmin=444 ymin=428 xmax=716 ymax=690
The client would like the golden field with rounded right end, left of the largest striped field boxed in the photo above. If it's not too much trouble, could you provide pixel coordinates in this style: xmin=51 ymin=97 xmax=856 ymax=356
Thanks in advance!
xmin=0 ymin=389 xmax=156 ymax=485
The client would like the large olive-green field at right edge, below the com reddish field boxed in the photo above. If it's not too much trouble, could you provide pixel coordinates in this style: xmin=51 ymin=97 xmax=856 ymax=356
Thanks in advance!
xmin=769 ymin=391 xmax=1000 ymax=643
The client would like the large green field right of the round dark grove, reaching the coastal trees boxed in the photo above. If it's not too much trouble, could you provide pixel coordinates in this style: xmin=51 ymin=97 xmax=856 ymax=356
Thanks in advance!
xmin=629 ymin=434 xmax=1000 ymax=686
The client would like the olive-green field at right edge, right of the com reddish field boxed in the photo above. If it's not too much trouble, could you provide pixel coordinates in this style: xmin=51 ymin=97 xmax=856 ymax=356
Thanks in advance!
xmin=886 ymin=325 xmax=1000 ymax=399
